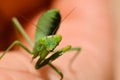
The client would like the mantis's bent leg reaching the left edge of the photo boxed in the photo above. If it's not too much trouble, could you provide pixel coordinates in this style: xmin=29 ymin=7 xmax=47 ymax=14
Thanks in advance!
xmin=0 ymin=40 xmax=32 ymax=59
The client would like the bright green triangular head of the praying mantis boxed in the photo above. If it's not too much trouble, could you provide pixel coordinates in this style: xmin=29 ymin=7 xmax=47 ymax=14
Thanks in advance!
xmin=40 ymin=35 xmax=62 ymax=51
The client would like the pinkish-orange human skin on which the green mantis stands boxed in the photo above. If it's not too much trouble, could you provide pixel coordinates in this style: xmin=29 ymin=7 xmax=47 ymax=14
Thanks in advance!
xmin=0 ymin=0 xmax=113 ymax=80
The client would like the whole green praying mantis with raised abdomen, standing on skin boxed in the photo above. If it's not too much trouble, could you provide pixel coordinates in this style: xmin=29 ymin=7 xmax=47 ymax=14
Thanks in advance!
xmin=0 ymin=9 xmax=81 ymax=80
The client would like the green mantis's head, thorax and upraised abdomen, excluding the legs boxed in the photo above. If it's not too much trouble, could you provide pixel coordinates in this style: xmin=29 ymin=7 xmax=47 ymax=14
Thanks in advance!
xmin=32 ymin=9 xmax=62 ymax=69
